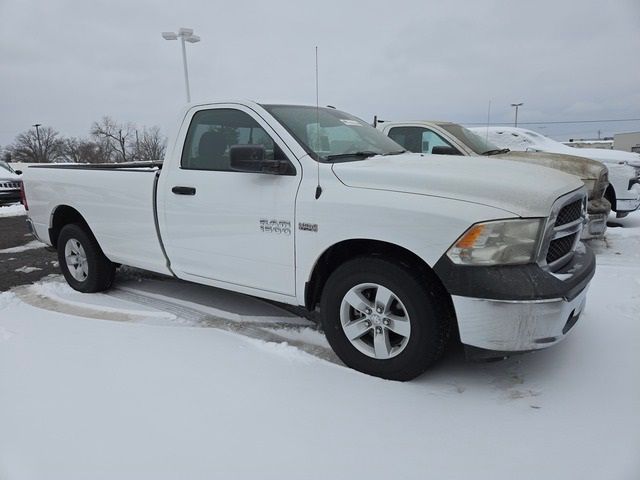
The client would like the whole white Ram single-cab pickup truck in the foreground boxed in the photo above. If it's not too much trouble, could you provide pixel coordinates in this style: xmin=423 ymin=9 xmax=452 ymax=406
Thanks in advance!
xmin=24 ymin=102 xmax=595 ymax=380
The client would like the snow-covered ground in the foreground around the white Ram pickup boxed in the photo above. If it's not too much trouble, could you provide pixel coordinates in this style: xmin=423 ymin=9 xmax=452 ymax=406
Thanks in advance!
xmin=0 ymin=214 xmax=640 ymax=480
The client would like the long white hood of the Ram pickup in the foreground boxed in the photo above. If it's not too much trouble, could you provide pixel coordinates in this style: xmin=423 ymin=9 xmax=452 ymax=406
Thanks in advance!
xmin=332 ymin=153 xmax=583 ymax=217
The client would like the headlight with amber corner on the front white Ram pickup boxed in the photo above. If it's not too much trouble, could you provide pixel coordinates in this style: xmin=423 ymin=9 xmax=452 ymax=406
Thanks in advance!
xmin=447 ymin=218 xmax=542 ymax=265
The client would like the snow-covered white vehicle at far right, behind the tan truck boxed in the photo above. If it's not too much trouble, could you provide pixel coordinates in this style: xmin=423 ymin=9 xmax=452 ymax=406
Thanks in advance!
xmin=471 ymin=127 xmax=640 ymax=217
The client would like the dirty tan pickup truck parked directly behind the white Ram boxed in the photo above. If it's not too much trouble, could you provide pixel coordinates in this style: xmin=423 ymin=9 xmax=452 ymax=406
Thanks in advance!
xmin=377 ymin=121 xmax=611 ymax=239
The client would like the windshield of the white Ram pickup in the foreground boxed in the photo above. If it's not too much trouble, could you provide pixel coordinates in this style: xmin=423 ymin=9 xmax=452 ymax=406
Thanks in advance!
xmin=263 ymin=105 xmax=405 ymax=162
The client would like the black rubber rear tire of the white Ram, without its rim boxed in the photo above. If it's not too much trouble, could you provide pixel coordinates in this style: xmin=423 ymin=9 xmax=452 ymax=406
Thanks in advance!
xmin=58 ymin=223 xmax=116 ymax=293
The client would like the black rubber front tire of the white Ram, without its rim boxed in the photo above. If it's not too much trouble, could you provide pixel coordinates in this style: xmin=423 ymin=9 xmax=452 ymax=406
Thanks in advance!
xmin=320 ymin=257 xmax=452 ymax=381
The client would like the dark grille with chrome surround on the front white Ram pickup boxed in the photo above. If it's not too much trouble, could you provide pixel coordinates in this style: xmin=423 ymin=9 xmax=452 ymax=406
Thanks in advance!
xmin=538 ymin=187 xmax=587 ymax=271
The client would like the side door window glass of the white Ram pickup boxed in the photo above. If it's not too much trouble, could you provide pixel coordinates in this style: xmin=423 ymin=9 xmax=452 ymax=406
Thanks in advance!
xmin=180 ymin=109 xmax=287 ymax=172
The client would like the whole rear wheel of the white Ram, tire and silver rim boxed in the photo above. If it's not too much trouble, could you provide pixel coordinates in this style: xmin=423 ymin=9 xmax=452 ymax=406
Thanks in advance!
xmin=58 ymin=224 xmax=116 ymax=293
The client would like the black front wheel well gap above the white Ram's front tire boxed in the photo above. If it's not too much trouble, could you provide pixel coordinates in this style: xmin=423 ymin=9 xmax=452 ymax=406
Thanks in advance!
xmin=304 ymin=239 xmax=456 ymax=316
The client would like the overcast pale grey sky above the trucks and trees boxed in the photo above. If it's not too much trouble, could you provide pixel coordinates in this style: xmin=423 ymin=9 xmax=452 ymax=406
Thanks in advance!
xmin=0 ymin=0 xmax=640 ymax=145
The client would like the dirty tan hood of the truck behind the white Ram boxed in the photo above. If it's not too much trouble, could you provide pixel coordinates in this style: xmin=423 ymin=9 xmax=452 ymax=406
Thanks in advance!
xmin=495 ymin=152 xmax=607 ymax=182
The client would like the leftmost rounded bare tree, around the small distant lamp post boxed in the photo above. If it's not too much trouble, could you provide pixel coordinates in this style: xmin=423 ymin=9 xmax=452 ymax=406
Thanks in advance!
xmin=6 ymin=127 xmax=63 ymax=163
